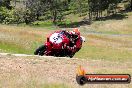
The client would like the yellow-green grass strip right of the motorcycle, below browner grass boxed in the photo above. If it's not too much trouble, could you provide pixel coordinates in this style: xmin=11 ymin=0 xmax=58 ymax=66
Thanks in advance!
xmin=75 ymin=45 xmax=132 ymax=61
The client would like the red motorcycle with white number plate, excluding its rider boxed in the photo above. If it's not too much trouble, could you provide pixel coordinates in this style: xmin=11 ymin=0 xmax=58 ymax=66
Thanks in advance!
xmin=34 ymin=31 xmax=84 ymax=58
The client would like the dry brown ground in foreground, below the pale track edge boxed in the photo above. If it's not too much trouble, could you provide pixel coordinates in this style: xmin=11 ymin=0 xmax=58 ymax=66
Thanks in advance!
xmin=0 ymin=53 xmax=132 ymax=88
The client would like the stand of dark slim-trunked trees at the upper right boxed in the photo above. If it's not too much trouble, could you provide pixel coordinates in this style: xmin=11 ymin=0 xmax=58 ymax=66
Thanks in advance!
xmin=88 ymin=0 xmax=121 ymax=20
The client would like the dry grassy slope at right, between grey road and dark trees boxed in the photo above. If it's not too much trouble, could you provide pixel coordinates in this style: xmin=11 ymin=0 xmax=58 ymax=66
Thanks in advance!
xmin=81 ymin=12 xmax=132 ymax=34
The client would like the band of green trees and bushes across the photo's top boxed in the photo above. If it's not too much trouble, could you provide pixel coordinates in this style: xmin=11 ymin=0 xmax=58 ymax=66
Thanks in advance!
xmin=0 ymin=0 xmax=131 ymax=25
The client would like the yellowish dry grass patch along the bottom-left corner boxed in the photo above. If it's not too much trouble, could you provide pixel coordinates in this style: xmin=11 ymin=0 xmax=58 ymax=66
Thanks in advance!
xmin=0 ymin=72 xmax=72 ymax=88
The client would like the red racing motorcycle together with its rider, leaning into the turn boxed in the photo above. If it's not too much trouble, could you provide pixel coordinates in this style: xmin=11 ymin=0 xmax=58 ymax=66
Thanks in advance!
xmin=34 ymin=28 xmax=84 ymax=58
